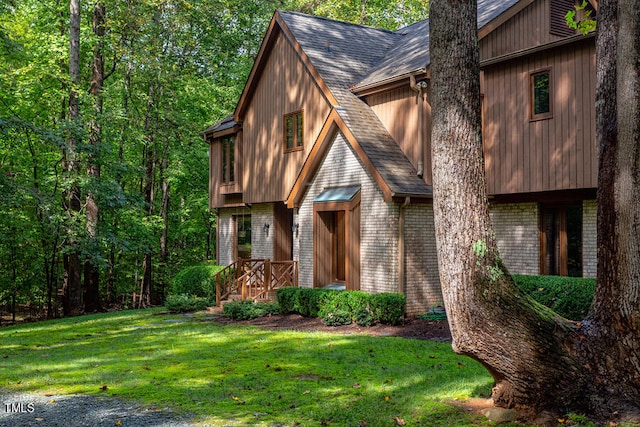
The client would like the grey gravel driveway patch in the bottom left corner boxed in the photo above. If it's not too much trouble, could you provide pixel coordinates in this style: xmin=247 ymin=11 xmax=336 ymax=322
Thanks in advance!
xmin=0 ymin=390 xmax=192 ymax=427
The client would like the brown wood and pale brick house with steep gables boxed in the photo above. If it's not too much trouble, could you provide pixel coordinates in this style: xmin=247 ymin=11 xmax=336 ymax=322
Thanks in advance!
xmin=204 ymin=0 xmax=597 ymax=313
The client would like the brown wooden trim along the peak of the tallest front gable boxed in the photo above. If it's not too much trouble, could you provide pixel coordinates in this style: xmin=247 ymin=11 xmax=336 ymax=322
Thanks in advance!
xmin=233 ymin=10 xmax=338 ymax=122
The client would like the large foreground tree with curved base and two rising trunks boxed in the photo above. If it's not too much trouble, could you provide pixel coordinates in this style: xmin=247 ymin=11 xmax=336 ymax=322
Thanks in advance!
xmin=430 ymin=0 xmax=640 ymax=419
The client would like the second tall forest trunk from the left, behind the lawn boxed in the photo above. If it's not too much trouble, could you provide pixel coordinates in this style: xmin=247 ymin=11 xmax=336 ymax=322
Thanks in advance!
xmin=84 ymin=2 xmax=105 ymax=312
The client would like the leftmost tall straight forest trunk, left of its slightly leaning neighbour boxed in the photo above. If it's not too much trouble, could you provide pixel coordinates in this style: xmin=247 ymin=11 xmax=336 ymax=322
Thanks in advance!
xmin=63 ymin=0 xmax=83 ymax=316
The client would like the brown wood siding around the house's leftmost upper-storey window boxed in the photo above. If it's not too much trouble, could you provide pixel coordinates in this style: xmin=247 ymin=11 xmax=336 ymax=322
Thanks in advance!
xmin=209 ymin=131 xmax=244 ymax=208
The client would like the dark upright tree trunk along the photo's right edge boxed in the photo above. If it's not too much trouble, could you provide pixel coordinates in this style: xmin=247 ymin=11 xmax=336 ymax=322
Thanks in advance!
xmin=581 ymin=0 xmax=640 ymax=415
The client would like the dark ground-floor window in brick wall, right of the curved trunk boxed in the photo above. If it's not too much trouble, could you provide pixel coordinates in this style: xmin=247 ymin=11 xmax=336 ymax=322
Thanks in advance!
xmin=540 ymin=205 xmax=582 ymax=277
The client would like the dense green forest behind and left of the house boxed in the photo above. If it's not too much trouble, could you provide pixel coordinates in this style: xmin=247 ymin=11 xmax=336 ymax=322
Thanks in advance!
xmin=0 ymin=0 xmax=428 ymax=317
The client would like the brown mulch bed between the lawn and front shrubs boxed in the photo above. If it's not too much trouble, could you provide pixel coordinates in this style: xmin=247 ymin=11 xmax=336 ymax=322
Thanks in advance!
xmin=210 ymin=314 xmax=451 ymax=342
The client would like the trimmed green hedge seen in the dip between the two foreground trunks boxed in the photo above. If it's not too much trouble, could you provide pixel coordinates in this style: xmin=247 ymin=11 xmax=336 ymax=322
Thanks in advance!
xmin=513 ymin=275 xmax=596 ymax=320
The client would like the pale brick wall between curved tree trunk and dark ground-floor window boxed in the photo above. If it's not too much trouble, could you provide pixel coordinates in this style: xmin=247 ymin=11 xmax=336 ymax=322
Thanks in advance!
xmin=490 ymin=203 xmax=540 ymax=275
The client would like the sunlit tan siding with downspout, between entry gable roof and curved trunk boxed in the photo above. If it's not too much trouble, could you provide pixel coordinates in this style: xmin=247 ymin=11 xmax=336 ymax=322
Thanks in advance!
xmin=366 ymin=86 xmax=431 ymax=185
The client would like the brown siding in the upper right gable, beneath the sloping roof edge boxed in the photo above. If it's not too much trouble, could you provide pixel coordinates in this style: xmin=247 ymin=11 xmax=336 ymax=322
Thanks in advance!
xmin=480 ymin=0 xmax=575 ymax=61
